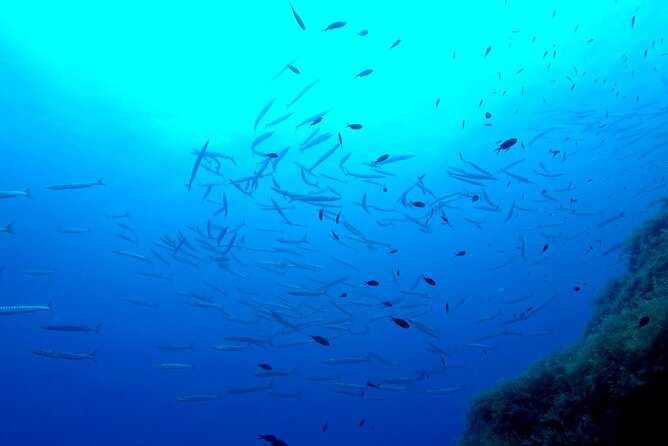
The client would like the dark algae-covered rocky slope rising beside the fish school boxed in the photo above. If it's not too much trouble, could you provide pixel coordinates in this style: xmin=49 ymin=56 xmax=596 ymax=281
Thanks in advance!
xmin=459 ymin=203 xmax=668 ymax=446
